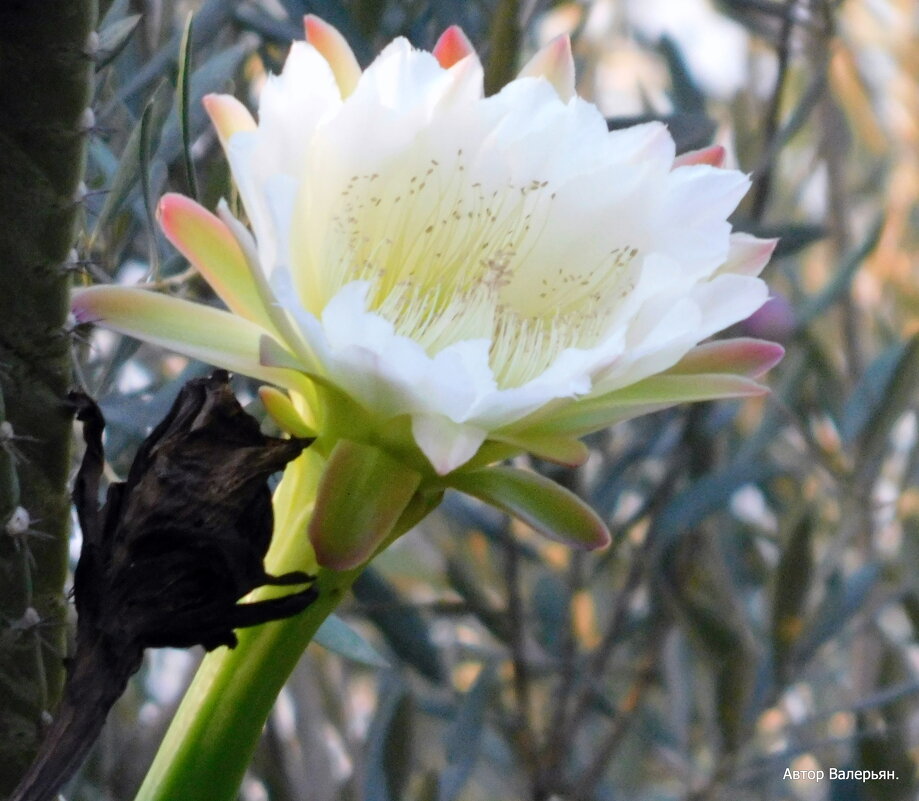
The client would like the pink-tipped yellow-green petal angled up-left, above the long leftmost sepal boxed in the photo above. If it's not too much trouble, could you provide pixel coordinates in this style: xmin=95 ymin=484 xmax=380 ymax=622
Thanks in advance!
xmin=156 ymin=193 xmax=273 ymax=330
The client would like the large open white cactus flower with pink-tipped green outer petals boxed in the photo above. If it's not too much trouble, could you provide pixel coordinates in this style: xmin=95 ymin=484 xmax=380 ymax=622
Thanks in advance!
xmin=73 ymin=17 xmax=782 ymax=567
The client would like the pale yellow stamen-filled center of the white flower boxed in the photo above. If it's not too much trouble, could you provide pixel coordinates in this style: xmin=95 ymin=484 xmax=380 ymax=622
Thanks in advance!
xmin=310 ymin=150 xmax=638 ymax=388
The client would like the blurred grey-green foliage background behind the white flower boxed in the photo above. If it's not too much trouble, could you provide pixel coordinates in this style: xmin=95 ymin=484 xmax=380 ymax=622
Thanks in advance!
xmin=52 ymin=0 xmax=919 ymax=801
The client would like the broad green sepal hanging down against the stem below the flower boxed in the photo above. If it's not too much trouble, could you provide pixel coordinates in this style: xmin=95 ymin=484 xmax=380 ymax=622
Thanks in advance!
xmin=309 ymin=439 xmax=421 ymax=570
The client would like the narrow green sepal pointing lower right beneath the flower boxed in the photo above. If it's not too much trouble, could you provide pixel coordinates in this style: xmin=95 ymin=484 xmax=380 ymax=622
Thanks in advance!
xmin=446 ymin=467 xmax=610 ymax=549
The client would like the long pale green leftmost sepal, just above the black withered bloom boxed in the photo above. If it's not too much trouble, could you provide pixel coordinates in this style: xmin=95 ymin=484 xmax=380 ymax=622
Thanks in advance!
xmin=71 ymin=286 xmax=305 ymax=388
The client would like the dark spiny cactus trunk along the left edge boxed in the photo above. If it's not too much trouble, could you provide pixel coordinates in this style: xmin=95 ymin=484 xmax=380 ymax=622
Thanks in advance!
xmin=0 ymin=0 xmax=96 ymax=797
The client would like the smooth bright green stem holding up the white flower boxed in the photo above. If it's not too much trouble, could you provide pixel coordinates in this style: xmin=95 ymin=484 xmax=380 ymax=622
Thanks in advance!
xmin=136 ymin=449 xmax=439 ymax=801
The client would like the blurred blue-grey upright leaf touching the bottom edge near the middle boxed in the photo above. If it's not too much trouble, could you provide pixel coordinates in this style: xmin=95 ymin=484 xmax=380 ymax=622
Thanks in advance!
xmin=437 ymin=665 xmax=497 ymax=801
